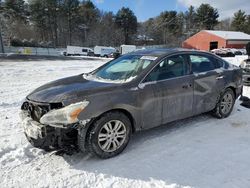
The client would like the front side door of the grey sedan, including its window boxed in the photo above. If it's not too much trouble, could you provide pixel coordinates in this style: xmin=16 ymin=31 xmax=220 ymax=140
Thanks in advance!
xmin=141 ymin=54 xmax=193 ymax=126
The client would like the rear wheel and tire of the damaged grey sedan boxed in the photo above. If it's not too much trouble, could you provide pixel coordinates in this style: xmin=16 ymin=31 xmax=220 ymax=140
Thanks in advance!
xmin=212 ymin=88 xmax=235 ymax=119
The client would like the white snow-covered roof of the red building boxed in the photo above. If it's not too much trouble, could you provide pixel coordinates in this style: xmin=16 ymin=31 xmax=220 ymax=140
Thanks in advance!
xmin=204 ymin=30 xmax=250 ymax=40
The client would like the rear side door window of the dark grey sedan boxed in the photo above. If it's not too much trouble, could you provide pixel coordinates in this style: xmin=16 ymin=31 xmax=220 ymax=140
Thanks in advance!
xmin=190 ymin=55 xmax=217 ymax=73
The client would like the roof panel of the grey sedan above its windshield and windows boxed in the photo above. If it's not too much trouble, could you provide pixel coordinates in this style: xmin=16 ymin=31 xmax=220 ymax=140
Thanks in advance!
xmin=130 ymin=48 xmax=207 ymax=57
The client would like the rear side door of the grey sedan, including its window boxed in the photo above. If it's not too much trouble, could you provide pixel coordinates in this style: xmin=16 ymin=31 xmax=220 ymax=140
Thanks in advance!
xmin=189 ymin=53 xmax=225 ymax=114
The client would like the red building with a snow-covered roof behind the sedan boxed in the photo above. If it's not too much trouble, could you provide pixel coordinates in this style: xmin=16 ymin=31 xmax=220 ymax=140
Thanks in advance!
xmin=182 ymin=30 xmax=250 ymax=51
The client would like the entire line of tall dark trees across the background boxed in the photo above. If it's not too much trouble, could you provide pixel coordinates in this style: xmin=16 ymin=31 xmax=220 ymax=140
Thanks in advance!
xmin=0 ymin=0 xmax=250 ymax=47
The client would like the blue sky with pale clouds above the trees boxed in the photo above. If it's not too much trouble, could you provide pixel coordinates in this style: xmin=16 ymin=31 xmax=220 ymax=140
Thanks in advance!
xmin=94 ymin=0 xmax=250 ymax=21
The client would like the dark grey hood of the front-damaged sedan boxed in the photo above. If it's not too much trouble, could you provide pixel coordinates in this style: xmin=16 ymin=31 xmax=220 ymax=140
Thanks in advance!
xmin=27 ymin=75 xmax=119 ymax=103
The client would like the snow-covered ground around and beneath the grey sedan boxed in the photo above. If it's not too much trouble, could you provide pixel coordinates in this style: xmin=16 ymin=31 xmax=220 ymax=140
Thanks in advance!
xmin=0 ymin=59 xmax=250 ymax=188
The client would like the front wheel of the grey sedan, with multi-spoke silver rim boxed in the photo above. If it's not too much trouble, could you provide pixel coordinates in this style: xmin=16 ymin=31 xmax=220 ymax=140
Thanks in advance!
xmin=83 ymin=112 xmax=131 ymax=159
